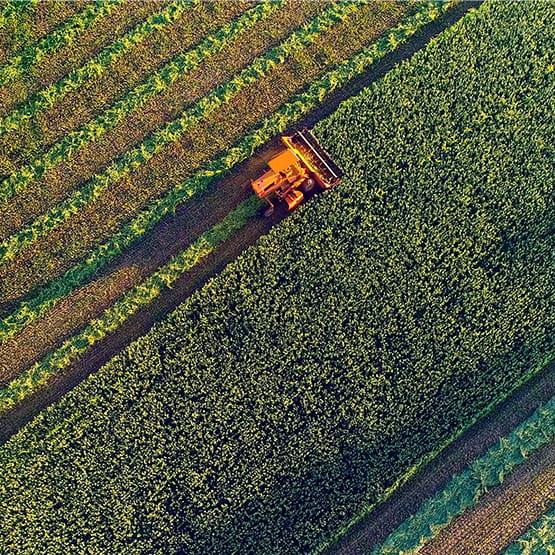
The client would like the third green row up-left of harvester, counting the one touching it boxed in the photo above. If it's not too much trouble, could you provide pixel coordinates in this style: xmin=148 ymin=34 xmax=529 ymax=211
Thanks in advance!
xmin=0 ymin=2 xmax=280 ymax=202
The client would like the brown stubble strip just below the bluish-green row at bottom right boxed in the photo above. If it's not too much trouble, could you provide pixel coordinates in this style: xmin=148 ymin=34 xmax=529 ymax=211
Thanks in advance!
xmin=419 ymin=442 xmax=555 ymax=555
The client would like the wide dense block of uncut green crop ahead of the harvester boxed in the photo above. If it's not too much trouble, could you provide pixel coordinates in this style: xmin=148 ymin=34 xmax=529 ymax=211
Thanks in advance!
xmin=0 ymin=2 xmax=555 ymax=553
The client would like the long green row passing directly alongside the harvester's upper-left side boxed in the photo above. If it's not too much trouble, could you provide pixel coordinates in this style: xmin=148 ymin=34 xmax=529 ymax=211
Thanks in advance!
xmin=0 ymin=2 xmax=451 ymax=341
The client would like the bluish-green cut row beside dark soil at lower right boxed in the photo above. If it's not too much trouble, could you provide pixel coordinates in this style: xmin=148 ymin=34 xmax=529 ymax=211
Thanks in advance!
xmin=372 ymin=398 xmax=555 ymax=555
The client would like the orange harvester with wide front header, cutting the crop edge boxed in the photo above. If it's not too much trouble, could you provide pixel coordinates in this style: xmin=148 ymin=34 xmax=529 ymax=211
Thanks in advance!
xmin=251 ymin=129 xmax=343 ymax=216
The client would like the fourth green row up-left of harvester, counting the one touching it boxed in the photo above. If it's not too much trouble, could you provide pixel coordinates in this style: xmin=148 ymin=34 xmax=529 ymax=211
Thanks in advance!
xmin=0 ymin=1 xmax=193 ymax=136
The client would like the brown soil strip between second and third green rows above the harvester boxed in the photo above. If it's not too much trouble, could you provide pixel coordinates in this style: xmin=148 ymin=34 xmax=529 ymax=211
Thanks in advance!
xmin=0 ymin=2 xmax=326 ymax=237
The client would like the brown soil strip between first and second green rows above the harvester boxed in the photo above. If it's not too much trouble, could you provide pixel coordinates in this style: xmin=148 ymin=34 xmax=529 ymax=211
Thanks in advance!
xmin=0 ymin=3 xmax=408 ymax=300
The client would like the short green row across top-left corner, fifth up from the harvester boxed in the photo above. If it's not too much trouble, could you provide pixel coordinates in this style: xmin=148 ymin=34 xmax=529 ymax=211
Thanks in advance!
xmin=0 ymin=0 xmax=118 ymax=85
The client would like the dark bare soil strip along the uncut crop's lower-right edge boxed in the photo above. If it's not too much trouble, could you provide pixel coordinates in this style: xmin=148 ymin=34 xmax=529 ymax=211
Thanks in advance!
xmin=326 ymin=361 xmax=555 ymax=555
